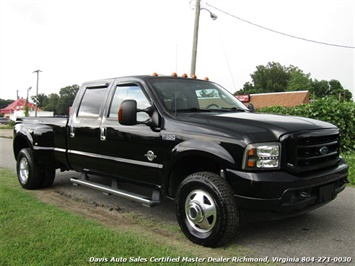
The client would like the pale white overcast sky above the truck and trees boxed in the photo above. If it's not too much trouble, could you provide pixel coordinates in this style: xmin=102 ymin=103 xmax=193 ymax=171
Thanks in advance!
xmin=0 ymin=0 xmax=355 ymax=99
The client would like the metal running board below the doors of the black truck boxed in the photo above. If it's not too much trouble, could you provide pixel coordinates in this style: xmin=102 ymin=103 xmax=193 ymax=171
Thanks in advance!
xmin=70 ymin=178 xmax=161 ymax=207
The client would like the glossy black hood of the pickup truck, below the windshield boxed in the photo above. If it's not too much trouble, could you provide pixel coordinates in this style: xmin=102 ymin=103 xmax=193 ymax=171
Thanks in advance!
xmin=177 ymin=112 xmax=336 ymax=142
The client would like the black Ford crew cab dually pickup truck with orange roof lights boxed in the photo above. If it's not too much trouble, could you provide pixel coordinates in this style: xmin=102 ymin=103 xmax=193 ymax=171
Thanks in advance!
xmin=13 ymin=75 xmax=348 ymax=247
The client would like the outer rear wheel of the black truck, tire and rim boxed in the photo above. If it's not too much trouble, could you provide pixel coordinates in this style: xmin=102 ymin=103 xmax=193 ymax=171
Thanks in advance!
xmin=16 ymin=148 xmax=42 ymax=189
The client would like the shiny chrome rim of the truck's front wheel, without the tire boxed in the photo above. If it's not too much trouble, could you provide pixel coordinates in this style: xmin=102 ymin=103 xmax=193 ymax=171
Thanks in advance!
xmin=185 ymin=190 xmax=217 ymax=233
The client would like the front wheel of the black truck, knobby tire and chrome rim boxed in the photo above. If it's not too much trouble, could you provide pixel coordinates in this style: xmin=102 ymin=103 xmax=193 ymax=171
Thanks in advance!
xmin=176 ymin=172 xmax=239 ymax=247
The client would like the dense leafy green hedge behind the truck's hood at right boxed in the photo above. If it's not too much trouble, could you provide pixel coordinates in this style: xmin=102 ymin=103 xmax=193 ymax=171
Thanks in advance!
xmin=258 ymin=98 xmax=355 ymax=151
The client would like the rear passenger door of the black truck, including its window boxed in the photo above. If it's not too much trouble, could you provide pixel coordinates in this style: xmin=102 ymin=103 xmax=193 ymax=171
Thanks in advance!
xmin=68 ymin=81 xmax=110 ymax=171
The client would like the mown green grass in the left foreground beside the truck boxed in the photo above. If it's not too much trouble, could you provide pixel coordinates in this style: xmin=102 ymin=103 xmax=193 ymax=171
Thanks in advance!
xmin=0 ymin=169 xmax=206 ymax=266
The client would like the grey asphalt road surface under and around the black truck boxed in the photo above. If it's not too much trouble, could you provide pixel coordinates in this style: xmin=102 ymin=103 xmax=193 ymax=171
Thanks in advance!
xmin=0 ymin=131 xmax=355 ymax=265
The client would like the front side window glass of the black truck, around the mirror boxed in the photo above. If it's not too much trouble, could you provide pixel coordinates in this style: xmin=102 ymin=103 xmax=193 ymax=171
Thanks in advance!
xmin=108 ymin=84 xmax=150 ymax=121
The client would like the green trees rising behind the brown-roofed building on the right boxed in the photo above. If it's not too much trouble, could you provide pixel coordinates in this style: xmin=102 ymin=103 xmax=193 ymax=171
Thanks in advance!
xmin=234 ymin=62 xmax=352 ymax=101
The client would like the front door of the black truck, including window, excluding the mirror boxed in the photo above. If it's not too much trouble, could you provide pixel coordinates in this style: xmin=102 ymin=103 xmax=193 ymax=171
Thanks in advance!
xmin=100 ymin=81 xmax=164 ymax=184
